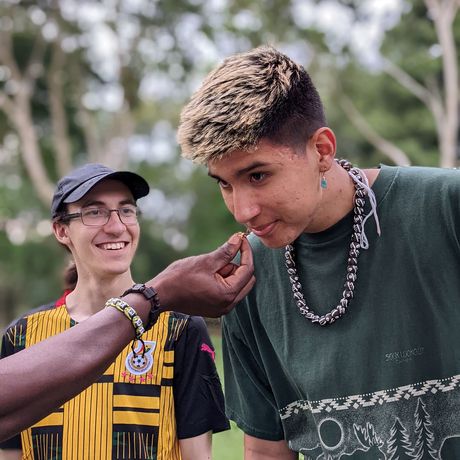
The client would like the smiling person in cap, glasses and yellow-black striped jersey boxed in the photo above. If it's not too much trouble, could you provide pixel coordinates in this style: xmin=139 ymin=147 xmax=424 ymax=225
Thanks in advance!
xmin=0 ymin=164 xmax=234 ymax=460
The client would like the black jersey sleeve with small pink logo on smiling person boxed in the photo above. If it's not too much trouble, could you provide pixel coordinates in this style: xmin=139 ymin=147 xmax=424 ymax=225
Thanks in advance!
xmin=174 ymin=316 xmax=230 ymax=439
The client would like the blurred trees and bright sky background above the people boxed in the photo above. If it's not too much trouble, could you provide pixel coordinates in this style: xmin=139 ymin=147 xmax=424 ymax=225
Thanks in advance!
xmin=0 ymin=0 xmax=460 ymax=326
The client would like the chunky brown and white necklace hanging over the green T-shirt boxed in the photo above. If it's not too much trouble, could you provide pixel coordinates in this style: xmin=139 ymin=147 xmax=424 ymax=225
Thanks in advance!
xmin=284 ymin=160 xmax=366 ymax=326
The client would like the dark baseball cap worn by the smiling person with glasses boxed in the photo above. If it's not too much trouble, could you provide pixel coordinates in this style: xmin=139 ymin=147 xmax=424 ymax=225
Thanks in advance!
xmin=51 ymin=163 xmax=150 ymax=219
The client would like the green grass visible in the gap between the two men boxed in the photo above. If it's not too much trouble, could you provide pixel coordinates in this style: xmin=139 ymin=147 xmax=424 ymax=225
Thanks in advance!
xmin=212 ymin=333 xmax=243 ymax=460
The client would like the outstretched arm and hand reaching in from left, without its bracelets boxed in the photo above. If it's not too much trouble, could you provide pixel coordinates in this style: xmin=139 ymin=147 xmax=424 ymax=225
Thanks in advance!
xmin=0 ymin=234 xmax=255 ymax=441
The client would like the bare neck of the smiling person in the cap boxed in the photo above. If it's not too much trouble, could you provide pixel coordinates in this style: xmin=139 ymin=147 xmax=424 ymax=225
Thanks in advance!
xmin=66 ymin=271 xmax=134 ymax=322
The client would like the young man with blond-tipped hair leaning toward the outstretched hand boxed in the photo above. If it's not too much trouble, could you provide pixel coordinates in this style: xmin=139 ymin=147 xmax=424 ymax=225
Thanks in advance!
xmin=178 ymin=47 xmax=460 ymax=460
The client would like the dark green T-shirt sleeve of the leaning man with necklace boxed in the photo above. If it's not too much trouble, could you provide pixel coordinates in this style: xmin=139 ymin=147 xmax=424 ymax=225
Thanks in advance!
xmin=222 ymin=301 xmax=284 ymax=441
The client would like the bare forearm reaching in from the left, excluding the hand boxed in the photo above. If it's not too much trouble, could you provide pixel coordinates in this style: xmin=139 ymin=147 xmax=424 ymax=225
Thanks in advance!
xmin=0 ymin=294 xmax=149 ymax=441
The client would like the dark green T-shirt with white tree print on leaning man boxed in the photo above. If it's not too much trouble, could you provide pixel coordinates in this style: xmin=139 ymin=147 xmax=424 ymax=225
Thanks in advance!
xmin=223 ymin=166 xmax=460 ymax=459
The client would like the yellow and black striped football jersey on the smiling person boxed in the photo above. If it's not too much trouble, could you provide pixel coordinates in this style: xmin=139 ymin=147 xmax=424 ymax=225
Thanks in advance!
xmin=0 ymin=300 xmax=229 ymax=460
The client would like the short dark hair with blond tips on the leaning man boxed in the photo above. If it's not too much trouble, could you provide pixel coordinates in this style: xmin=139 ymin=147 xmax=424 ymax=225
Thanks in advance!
xmin=178 ymin=47 xmax=326 ymax=163
